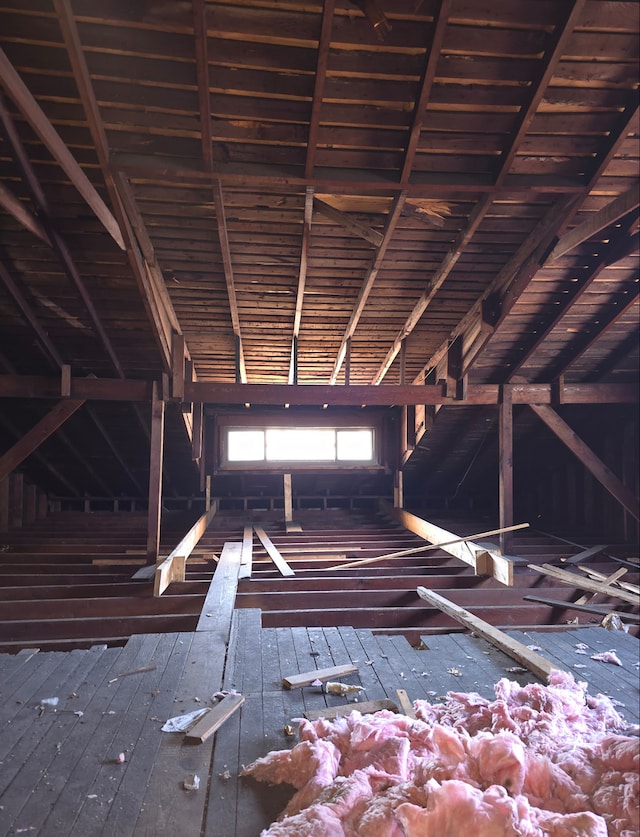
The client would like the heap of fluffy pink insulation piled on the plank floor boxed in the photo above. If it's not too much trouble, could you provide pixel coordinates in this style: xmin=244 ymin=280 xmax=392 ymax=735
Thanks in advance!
xmin=242 ymin=671 xmax=640 ymax=837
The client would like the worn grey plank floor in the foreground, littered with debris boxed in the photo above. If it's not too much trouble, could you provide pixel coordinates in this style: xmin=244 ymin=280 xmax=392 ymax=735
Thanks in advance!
xmin=0 ymin=609 xmax=640 ymax=837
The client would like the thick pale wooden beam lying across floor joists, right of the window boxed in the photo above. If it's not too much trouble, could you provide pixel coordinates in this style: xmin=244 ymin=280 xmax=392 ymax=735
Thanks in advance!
xmin=384 ymin=504 xmax=516 ymax=587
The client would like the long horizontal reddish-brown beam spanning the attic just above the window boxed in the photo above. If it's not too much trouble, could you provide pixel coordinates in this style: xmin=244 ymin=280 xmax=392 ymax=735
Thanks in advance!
xmin=0 ymin=375 xmax=638 ymax=407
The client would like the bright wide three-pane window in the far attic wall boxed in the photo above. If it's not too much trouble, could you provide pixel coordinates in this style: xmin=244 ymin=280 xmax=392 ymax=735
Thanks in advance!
xmin=225 ymin=427 xmax=377 ymax=466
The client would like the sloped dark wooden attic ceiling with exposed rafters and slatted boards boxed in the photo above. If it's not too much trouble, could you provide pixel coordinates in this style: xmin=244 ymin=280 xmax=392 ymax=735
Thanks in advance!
xmin=0 ymin=0 xmax=640 ymax=502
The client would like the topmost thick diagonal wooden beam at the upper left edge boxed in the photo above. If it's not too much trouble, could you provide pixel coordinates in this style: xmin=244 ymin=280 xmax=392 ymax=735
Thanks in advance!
xmin=0 ymin=49 xmax=125 ymax=250
